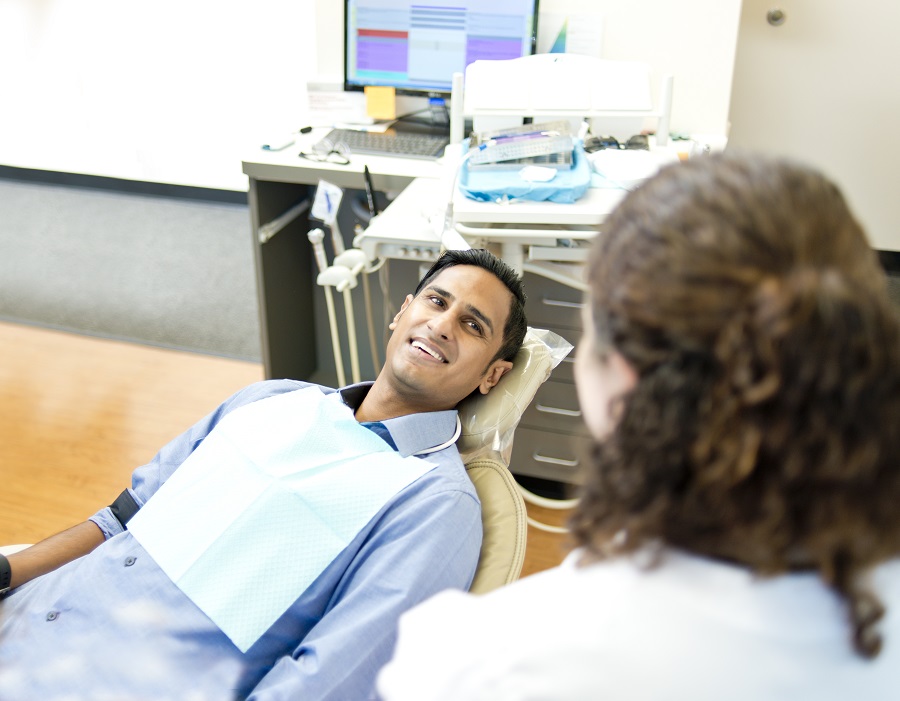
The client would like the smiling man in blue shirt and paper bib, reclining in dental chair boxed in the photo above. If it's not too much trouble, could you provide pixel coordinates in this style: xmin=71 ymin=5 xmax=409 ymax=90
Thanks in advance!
xmin=0 ymin=251 xmax=526 ymax=701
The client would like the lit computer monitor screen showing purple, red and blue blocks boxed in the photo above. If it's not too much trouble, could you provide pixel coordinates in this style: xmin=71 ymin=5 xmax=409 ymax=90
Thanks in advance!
xmin=344 ymin=0 xmax=538 ymax=95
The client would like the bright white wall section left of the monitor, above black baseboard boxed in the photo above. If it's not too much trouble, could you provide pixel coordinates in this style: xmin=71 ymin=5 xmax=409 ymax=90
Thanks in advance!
xmin=0 ymin=0 xmax=315 ymax=190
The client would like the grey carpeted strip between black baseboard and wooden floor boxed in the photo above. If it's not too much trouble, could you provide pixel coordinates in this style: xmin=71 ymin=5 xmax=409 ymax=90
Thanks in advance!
xmin=0 ymin=179 xmax=261 ymax=361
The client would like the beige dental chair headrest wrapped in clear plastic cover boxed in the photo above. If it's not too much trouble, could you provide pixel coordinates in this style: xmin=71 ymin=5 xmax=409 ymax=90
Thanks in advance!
xmin=456 ymin=328 xmax=572 ymax=464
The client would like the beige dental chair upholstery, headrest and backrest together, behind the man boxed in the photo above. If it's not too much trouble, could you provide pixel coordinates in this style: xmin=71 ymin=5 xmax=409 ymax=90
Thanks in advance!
xmin=457 ymin=329 xmax=553 ymax=594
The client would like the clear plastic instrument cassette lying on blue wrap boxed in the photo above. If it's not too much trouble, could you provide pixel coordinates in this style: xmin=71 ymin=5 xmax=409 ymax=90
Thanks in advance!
xmin=469 ymin=120 xmax=574 ymax=166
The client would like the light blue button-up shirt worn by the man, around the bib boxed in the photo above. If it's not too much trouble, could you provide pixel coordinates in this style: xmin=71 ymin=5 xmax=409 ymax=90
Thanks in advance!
xmin=0 ymin=380 xmax=481 ymax=701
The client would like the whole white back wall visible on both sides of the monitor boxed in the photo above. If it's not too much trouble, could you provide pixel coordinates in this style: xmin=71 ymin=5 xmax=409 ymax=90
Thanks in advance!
xmin=0 ymin=0 xmax=740 ymax=190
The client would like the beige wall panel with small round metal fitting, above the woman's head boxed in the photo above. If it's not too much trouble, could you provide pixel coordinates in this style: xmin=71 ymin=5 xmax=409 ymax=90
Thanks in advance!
xmin=729 ymin=0 xmax=900 ymax=251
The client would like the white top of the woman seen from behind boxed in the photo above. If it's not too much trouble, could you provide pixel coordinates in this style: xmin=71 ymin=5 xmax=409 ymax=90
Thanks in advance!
xmin=378 ymin=552 xmax=900 ymax=701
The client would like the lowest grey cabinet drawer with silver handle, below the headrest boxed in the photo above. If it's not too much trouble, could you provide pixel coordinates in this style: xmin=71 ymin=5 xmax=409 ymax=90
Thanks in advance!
xmin=509 ymin=426 xmax=591 ymax=484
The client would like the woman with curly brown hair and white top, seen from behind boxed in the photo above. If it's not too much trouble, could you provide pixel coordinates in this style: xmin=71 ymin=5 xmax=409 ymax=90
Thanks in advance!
xmin=379 ymin=154 xmax=900 ymax=701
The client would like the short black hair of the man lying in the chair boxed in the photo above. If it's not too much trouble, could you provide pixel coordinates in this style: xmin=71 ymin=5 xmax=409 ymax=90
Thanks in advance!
xmin=415 ymin=248 xmax=528 ymax=363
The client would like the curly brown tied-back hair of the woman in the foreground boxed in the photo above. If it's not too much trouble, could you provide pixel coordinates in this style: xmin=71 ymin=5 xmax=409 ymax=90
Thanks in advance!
xmin=571 ymin=154 xmax=900 ymax=657
